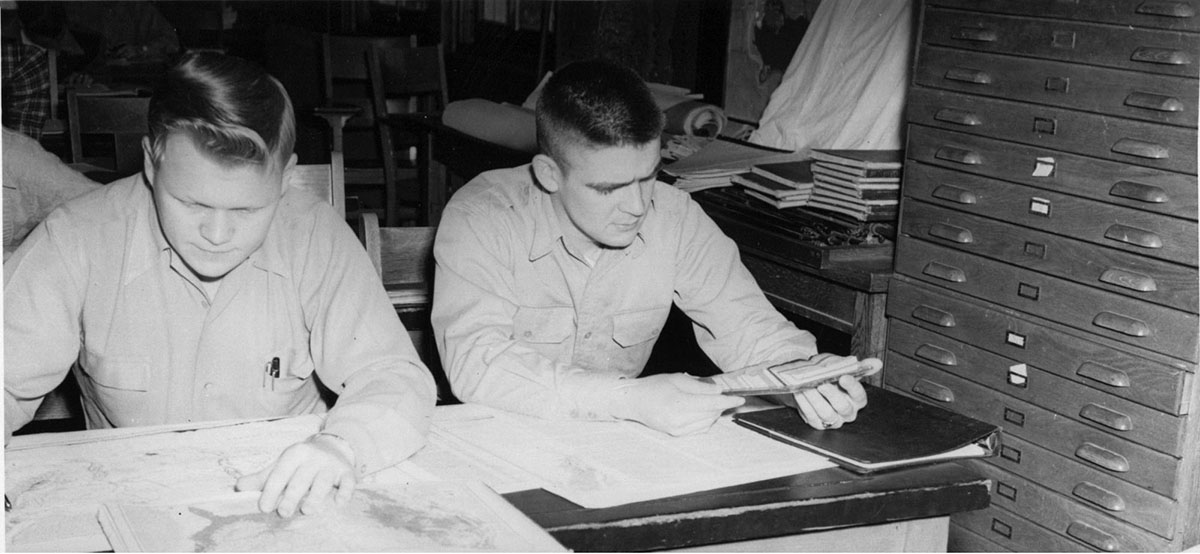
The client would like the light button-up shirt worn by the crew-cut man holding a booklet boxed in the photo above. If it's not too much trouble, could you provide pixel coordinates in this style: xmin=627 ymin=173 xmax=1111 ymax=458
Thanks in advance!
xmin=432 ymin=165 xmax=817 ymax=418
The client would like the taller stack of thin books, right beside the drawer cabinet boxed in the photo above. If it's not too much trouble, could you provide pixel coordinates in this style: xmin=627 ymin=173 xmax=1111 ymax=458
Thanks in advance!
xmin=806 ymin=150 xmax=904 ymax=222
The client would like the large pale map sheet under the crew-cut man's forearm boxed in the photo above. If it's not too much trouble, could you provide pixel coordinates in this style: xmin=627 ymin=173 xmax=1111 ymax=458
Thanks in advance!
xmin=414 ymin=404 xmax=834 ymax=508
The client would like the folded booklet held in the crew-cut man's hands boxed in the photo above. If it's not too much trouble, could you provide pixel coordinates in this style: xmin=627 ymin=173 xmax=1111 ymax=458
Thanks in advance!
xmin=701 ymin=354 xmax=883 ymax=396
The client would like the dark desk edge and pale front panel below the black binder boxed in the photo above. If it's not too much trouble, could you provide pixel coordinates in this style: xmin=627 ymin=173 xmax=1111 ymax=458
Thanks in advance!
xmin=505 ymin=463 xmax=989 ymax=552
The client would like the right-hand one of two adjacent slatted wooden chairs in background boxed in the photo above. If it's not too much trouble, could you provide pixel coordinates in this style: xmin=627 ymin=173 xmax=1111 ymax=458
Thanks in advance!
xmin=367 ymin=43 xmax=448 ymax=225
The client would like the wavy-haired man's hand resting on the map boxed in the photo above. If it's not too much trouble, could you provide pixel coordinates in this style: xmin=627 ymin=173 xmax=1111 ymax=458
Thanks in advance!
xmin=235 ymin=433 xmax=358 ymax=517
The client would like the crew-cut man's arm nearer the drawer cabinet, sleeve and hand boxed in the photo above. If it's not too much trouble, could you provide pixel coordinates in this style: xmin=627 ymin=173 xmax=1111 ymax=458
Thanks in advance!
xmin=676 ymin=193 xmax=866 ymax=429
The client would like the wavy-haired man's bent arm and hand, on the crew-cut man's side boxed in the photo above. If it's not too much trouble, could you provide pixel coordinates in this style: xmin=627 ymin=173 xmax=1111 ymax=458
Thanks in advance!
xmin=231 ymin=201 xmax=437 ymax=517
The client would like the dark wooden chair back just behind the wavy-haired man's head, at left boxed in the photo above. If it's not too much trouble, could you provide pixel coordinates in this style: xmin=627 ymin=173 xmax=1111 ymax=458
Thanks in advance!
xmin=67 ymin=90 xmax=150 ymax=179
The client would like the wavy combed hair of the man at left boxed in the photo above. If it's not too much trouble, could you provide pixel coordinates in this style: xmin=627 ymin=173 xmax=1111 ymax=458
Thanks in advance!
xmin=149 ymin=52 xmax=296 ymax=168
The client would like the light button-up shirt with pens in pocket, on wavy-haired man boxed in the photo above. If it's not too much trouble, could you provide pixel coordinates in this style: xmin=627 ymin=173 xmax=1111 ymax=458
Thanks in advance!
xmin=4 ymin=175 xmax=436 ymax=472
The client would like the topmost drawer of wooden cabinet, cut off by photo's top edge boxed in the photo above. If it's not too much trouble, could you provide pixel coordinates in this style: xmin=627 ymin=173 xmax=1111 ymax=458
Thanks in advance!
xmin=929 ymin=0 xmax=1200 ymax=31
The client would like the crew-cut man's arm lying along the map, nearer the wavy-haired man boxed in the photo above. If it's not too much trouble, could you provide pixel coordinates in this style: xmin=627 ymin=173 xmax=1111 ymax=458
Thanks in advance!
xmin=432 ymin=185 xmax=742 ymax=434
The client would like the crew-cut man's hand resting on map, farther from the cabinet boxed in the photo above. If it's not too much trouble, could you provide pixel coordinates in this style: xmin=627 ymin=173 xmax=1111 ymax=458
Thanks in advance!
xmin=612 ymin=373 xmax=745 ymax=436
